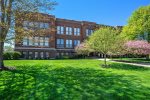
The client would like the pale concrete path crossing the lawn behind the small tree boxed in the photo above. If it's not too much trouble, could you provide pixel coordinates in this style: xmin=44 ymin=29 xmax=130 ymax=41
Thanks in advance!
xmin=98 ymin=59 xmax=150 ymax=68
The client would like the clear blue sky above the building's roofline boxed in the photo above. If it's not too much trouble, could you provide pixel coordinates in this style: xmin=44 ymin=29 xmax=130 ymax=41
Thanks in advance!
xmin=51 ymin=0 xmax=150 ymax=26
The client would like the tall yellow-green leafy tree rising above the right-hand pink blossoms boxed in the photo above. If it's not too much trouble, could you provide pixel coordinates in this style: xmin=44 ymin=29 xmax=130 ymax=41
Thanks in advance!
xmin=122 ymin=5 xmax=150 ymax=42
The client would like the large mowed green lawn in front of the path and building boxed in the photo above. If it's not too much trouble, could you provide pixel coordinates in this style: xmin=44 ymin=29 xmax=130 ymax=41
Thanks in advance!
xmin=0 ymin=60 xmax=150 ymax=100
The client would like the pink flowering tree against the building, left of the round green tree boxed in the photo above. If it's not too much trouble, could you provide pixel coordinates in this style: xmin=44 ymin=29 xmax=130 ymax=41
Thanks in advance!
xmin=75 ymin=42 xmax=93 ymax=56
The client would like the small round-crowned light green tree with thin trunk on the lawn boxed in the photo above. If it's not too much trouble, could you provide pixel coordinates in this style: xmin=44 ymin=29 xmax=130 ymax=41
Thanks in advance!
xmin=88 ymin=28 xmax=120 ymax=66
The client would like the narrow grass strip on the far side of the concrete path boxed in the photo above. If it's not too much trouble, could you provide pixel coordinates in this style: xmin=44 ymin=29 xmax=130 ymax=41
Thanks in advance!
xmin=113 ymin=58 xmax=150 ymax=64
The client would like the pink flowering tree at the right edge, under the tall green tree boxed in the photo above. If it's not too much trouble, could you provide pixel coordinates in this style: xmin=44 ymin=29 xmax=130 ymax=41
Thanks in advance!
xmin=125 ymin=40 xmax=150 ymax=55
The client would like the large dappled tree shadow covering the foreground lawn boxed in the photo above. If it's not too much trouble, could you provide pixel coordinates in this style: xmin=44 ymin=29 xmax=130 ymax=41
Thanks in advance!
xmin=0 ymin=66 xmax=150 ymax=100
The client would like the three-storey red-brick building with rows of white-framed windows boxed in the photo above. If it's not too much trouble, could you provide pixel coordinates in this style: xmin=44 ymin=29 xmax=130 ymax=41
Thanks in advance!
xmin=15 ymin=13 xmax=102 ymax=59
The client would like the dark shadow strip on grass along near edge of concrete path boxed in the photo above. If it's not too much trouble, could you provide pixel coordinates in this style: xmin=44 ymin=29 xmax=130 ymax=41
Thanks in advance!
xmin=110 ymin=63 xmax=150 ymax=71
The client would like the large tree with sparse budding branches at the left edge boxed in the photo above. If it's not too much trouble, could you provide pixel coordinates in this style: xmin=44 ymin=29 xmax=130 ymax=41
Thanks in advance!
xmin=0 ymin=0 xmax=56 ymax=69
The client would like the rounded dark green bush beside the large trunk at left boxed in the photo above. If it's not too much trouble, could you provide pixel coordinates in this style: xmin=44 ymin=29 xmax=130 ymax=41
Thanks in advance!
xmin=3 ymin=51 xmax=21 ymax=60
